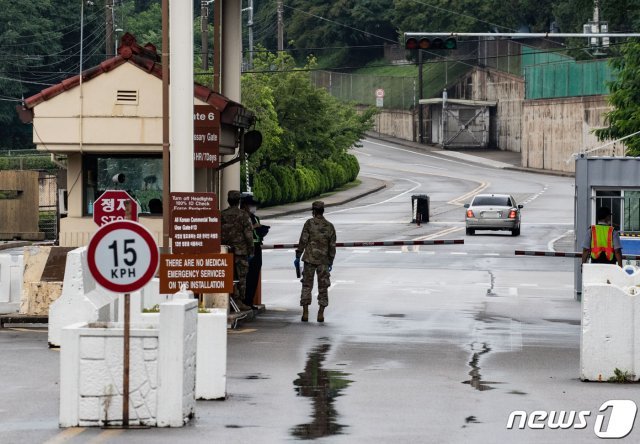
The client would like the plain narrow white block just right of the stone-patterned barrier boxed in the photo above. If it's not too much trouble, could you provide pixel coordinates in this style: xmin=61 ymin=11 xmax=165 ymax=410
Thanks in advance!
xmin=196 ymin=308 xmax=227 ymax=399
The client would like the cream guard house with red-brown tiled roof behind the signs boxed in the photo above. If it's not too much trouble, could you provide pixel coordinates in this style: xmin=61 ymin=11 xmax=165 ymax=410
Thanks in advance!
xmin=19 ymin=34 xmax=254 ymax=247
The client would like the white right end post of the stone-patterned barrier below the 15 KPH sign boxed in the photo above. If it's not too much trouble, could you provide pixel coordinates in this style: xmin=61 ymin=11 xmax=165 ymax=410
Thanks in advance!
xmin=158 ymin=299 xmax=198 ymax=427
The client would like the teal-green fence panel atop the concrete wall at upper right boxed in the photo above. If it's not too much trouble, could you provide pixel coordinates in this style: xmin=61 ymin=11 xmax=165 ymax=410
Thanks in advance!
xmin=522 ymin=46 xmax=615 ymax=99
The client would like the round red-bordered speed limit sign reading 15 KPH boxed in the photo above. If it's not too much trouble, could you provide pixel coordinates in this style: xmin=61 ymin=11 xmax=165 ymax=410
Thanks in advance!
xmin=87 ymin=220 xmax=159 ymax=293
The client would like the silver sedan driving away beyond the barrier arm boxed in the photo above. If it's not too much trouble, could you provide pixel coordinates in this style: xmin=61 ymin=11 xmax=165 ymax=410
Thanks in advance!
xmin=464 ymin=194 xmax=523 ymax=236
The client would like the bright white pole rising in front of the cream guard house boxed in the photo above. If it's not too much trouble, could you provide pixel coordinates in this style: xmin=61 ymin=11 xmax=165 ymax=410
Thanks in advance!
xmin=169 ymin=0 xmax=194 ymax=192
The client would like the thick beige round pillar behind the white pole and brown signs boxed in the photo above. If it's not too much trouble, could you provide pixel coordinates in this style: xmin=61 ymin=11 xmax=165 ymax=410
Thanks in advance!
xmin=219 ymin=0 xmax=242 ymax=198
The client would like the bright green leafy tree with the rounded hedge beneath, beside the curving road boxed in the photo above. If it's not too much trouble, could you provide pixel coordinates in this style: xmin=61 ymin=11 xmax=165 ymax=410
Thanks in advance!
xmin=242 ymin=47 xmax=375 ymax=205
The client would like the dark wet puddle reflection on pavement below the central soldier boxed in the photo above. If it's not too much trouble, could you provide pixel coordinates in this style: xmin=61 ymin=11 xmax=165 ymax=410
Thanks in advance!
xmin=291 ymin=344 xmax=352 ymax=439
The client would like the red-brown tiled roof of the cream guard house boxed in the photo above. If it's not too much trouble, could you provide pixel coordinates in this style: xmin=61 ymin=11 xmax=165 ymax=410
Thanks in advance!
xmin=18 ymin=33 xmax=255 ymax=129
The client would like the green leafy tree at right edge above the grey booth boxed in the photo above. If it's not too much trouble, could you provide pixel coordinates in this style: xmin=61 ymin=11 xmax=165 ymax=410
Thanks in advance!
xmin=595 ymin=41 xmax=640 ymax=156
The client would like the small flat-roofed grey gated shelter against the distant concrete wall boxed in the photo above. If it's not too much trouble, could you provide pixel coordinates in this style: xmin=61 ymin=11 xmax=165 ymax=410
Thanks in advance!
xmin=420 ymin=94 xmax=497 ymax=149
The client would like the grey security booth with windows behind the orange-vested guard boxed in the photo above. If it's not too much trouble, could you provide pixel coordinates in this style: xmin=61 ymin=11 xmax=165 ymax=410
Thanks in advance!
xmin=574 ymin=154 xmax=640 ymax=300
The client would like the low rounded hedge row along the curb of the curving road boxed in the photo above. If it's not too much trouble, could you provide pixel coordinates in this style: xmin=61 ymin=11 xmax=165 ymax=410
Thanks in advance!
xmin=253 ymin=154 xmax=360 ymax=206
